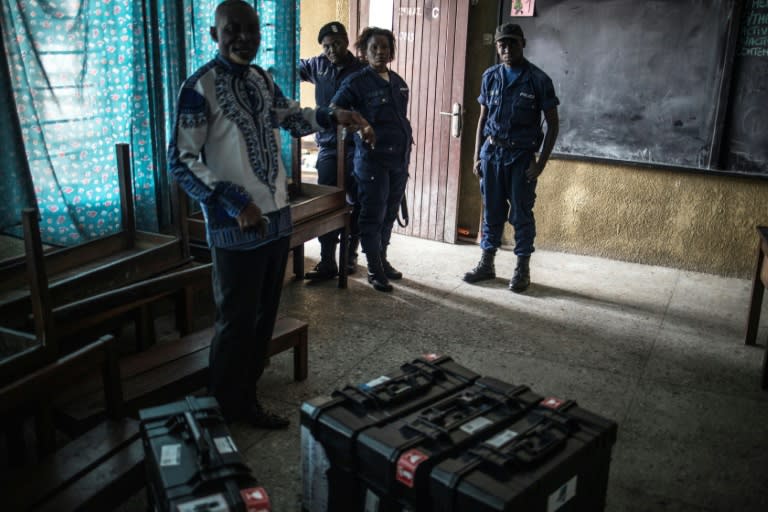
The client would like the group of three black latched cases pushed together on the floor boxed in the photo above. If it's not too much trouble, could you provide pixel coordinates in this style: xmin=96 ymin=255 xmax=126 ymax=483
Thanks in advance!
xmin=301 ymin=356 xmax=617 ymax=512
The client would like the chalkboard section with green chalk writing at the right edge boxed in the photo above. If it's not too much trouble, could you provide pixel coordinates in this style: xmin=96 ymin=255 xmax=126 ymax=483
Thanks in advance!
xmin=723 ymin=0 xmax=768 ymax=176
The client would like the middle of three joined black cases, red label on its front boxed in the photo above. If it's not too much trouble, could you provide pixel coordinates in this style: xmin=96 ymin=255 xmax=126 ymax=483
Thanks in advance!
xmin=357 ymin=378 xmax=542 ymax=512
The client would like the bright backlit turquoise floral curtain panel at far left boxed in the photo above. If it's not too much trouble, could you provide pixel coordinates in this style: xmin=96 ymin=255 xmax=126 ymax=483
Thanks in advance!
xmin=2 ymin=0 xmax=157 ymax=245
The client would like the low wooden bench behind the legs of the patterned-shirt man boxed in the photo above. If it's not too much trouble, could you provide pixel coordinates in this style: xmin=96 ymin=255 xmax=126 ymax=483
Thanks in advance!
xmin=57 ymin=317 xmax=308 ymax=432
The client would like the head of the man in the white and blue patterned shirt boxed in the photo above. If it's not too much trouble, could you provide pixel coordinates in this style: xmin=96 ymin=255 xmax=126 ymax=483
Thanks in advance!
xmin=211 ymin=4 xmax=261 ymax=65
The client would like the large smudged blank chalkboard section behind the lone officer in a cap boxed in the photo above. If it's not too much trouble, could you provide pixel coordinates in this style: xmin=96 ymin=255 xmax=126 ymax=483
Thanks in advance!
xmin=501 ymin=0 xmax=736 ymax=168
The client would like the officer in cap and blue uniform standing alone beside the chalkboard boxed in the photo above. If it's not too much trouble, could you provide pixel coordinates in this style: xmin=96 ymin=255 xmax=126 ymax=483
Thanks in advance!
xmin=464 ymin=23 xmax=560 ymax=293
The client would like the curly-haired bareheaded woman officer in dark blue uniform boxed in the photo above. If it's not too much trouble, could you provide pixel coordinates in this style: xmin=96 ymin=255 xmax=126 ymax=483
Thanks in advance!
xmin=331 ymin=27 xmax=413 ymax=292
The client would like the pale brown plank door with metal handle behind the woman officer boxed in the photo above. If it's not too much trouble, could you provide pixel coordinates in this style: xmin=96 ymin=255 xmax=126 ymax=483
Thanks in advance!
xmin=350 ymin=0 xmax=474 ymax=242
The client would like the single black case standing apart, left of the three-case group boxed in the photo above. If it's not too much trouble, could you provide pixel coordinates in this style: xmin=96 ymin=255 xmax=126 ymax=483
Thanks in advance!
xmin=139 ymin=397 xmax=271 ymax=512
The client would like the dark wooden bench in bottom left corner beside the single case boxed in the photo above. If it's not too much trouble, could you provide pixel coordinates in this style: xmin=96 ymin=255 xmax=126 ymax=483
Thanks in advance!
xmin=0 ymin=337 xmax=144 ymax=511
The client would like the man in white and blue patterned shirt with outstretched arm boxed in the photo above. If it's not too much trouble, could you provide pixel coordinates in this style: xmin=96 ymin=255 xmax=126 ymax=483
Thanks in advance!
xmin=168 ymin=0 xmax=374 ymax=428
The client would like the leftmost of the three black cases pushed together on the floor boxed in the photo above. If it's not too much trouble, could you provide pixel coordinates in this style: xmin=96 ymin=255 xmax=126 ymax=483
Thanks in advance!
xmin=301 ymin=354 xmax=479 ymax=512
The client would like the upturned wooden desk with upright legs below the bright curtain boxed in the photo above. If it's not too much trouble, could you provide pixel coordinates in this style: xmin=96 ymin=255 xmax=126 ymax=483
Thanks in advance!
xmin=0 ymin=144 xmax=191 ymax=382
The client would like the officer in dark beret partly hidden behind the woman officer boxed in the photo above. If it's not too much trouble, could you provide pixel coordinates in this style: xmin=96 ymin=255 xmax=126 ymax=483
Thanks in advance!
xmin=299 ymin=21 xmax=365 ymax=280
